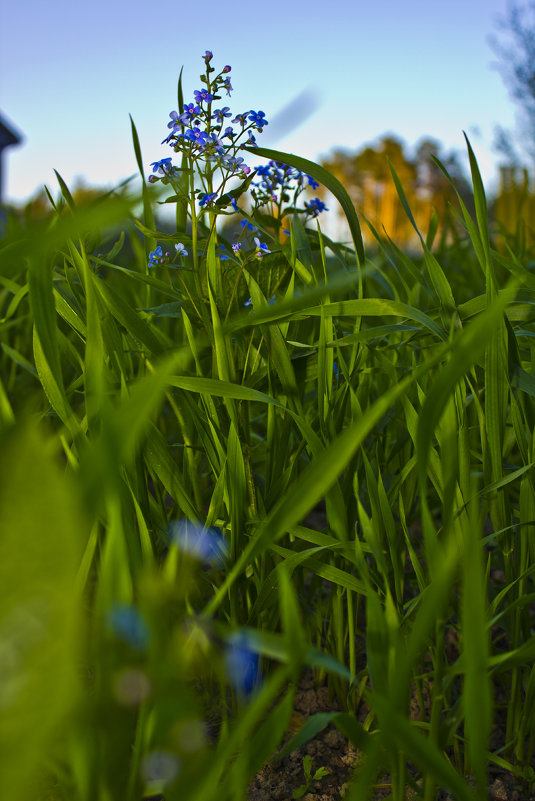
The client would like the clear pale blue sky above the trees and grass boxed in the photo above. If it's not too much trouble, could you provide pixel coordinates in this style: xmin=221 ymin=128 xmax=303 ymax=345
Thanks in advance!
xmin=0 ymin=0 xmax=515 ymax=202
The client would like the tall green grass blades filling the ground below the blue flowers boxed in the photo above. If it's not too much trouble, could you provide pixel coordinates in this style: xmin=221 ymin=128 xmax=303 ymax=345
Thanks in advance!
xmin=0 ymin=61 xmax=535 ymax=801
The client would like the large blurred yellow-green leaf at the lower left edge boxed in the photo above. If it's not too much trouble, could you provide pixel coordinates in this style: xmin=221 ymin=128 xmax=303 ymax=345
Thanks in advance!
xmin=0 ymin=423 xmax=85 ymax=801
